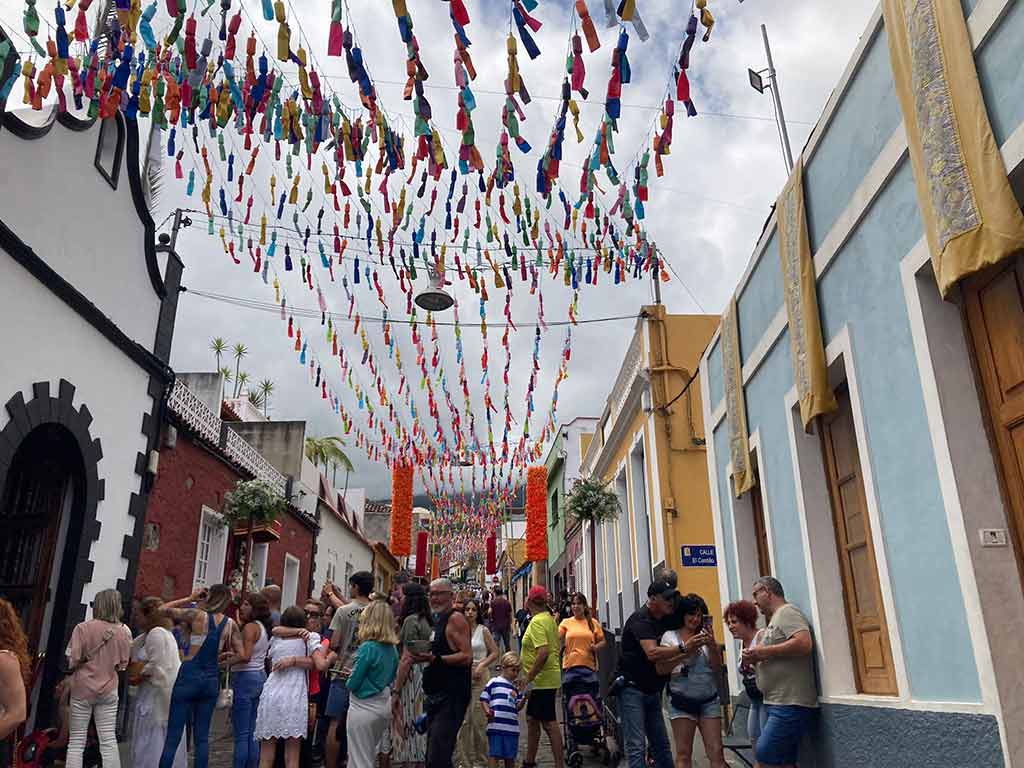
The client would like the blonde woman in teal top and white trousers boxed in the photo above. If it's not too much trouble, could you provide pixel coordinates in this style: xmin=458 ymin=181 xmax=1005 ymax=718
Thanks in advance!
xmin=345 ymin=600 xmax=398 ymax=768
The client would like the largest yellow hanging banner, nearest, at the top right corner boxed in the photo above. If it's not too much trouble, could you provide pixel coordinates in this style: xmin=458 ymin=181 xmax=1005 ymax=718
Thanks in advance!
xmin=882 ymin=0 xmax=1024 ymax=297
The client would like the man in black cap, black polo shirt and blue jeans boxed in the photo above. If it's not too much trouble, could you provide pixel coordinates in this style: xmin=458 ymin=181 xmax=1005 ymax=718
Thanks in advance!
xmin=615 ymin=570 xmax=693 ymax=768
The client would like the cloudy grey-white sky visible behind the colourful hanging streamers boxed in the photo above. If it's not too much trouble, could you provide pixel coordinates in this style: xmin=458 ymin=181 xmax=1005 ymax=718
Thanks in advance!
xmin=0 ymin=0 xmax=877 ymax=498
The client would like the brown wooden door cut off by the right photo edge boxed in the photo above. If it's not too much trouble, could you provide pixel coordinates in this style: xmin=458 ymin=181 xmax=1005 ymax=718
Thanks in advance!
xmin=963 ymin=258 xmax=1024 ymax=577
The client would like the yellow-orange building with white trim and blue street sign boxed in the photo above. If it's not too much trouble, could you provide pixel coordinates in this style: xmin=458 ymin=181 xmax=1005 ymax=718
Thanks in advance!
xmin=582 ymin=305 xmax=723 ymax=638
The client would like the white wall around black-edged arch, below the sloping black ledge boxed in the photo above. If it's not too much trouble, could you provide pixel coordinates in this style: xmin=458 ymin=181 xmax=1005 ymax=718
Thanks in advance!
xmin=0 ymin=256 xmax=153 ymax=604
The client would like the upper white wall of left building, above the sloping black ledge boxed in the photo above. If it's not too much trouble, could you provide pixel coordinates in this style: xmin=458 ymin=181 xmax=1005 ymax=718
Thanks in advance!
xmin=0 ymin=112 xmax=160 ymax=349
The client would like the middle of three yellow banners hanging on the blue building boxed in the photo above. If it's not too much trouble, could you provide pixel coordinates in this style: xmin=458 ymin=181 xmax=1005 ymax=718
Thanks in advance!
xmin=775 ymin=158 xmax=838 ymax=429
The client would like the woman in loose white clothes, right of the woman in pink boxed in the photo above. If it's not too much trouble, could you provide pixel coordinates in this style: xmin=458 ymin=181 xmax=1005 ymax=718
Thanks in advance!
xmin=128 ymin=597 xmax=187 ymax=768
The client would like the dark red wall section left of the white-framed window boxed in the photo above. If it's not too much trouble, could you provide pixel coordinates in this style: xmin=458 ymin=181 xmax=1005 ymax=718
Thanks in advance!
xmin=135 ymin=430 xmax=241 ymax=600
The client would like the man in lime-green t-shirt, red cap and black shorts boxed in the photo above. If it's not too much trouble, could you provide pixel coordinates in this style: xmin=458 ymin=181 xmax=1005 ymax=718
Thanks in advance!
xmin=522 ymin=586 xmax=565 ymax=768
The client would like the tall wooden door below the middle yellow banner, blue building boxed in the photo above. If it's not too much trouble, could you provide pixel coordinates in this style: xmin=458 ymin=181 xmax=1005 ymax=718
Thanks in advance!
xmin=821 ymin=386 xmax=899 ymax=695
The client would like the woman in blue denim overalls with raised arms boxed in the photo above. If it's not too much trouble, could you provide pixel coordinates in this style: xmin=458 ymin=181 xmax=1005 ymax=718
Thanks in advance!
xmin=160 ymin=584 xmax=243 ymax=768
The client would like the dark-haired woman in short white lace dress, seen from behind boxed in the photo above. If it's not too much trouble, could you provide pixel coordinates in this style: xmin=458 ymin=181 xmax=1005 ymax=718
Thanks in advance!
xmin=253 ymin=605 xmax=322 ymax=768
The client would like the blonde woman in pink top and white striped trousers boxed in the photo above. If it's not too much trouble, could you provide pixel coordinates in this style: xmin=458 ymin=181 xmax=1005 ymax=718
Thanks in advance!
xmin=66 ymin=590 xmax=131 ymax=768
